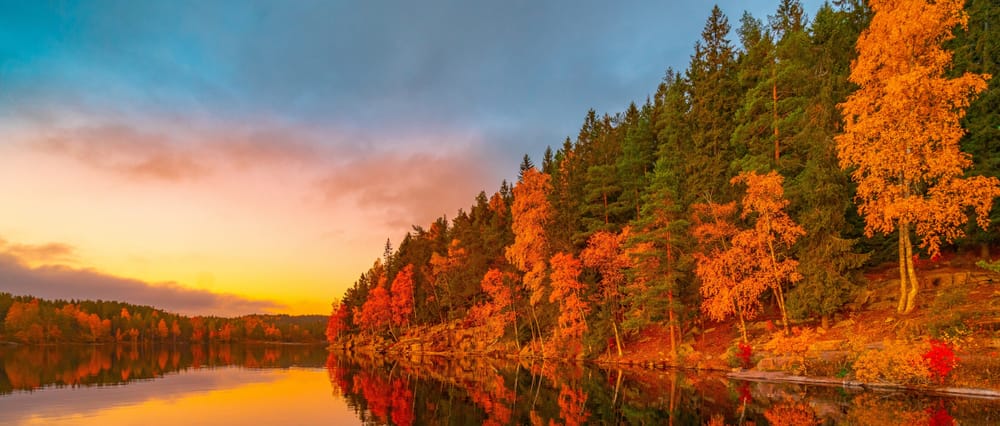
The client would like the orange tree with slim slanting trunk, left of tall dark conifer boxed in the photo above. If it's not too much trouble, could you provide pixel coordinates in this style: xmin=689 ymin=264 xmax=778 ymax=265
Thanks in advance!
xmin=731 ymin=171 xmax=806 ymax=334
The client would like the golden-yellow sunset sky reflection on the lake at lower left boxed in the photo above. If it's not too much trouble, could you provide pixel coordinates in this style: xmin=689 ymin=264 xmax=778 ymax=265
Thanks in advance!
xmin=4 ymin=367 xmax=359 ymax=425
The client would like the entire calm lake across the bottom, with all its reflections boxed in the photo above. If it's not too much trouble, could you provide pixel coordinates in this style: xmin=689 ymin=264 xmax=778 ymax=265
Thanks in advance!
xmin=0 ymin=345 xmax=1000 ymax=425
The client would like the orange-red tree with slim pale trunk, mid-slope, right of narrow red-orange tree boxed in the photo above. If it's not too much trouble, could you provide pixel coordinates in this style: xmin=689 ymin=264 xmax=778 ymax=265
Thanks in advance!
xmin=580 ymin=228 xmax=632 ymax=356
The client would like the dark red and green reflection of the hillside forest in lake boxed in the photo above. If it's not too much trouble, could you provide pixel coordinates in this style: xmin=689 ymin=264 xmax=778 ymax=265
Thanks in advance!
xmin=327 ymin=354 xmax=1000 ymax=426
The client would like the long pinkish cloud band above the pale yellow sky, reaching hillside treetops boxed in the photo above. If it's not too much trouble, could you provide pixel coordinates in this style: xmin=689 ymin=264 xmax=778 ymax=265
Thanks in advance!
xmin=32 ymin=115 xmax=502 ymax=229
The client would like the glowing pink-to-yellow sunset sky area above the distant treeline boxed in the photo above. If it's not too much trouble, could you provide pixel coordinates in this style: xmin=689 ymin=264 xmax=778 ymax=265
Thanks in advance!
xmin=0 ymin=127 xmax=496 ymax=314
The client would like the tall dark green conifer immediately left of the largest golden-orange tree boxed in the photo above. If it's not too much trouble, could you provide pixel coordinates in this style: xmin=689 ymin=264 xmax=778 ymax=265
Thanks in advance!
xmin=786 ymin=1 xmax=869 ymax=326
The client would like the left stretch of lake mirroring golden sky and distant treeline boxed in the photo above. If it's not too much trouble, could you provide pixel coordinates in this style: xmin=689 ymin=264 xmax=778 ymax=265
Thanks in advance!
xmin=0 ymin=345 xmax=360 ymax=425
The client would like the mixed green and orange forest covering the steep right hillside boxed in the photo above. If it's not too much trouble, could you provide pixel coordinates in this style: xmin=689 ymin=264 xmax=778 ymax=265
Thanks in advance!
xmin=326 ymin=0 xmax=1000 ymax=359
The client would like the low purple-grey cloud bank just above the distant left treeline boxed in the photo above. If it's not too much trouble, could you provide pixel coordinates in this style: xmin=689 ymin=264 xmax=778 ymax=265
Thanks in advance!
xmin=0 ymin=243 xmax=288 ymax=316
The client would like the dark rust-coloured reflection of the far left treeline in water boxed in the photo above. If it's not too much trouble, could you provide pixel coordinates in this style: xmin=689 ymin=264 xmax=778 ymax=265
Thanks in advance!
xmin=0 ymin=344 xmax=326 ymax=395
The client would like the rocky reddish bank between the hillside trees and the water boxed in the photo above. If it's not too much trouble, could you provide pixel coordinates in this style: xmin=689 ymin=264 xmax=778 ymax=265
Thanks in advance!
xmin=328 ymin=257 xmax=1000 ymax=399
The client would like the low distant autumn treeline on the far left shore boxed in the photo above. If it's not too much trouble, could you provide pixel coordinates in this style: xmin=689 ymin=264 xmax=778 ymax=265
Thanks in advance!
xmin=0 ymin=293 xmax=326 ymax=344
